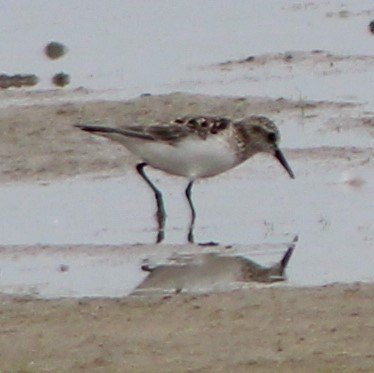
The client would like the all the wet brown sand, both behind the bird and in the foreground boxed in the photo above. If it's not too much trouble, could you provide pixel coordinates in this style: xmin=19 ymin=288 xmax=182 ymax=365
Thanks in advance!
xmin=0 ymin=94 xmax=374 ymax=372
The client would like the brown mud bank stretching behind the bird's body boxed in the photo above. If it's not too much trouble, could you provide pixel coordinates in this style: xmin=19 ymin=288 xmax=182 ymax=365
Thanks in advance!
xmin=0 ymin=93 xmax=373 ymax=182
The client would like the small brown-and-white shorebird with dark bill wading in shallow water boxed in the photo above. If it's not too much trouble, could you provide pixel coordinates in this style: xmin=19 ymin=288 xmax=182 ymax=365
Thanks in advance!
xmin=76 ymin=116 xmax=295 ymax=242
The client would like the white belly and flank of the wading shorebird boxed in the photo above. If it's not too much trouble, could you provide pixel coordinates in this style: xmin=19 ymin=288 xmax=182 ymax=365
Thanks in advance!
xmin=121 ymin=136 xmax=239 ymax=180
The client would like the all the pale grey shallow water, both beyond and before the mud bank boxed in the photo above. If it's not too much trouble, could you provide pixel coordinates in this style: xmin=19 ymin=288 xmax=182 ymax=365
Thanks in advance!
xmin=0 ymin=0 xmax=374 ymax=297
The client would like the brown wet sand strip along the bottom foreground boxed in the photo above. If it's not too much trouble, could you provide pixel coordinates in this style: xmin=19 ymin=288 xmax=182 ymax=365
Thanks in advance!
xmin=0 ymin=284 xmax=374 ymax=373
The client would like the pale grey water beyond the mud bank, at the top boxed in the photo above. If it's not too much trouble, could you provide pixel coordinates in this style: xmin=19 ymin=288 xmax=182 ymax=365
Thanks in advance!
xmin=0 ymin=0 xmax=374 ymax=110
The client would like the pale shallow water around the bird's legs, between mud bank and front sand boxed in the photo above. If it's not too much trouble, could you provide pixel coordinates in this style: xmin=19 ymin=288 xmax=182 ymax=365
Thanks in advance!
xmin=0 ymin=153 xmax=374 ymax=295
